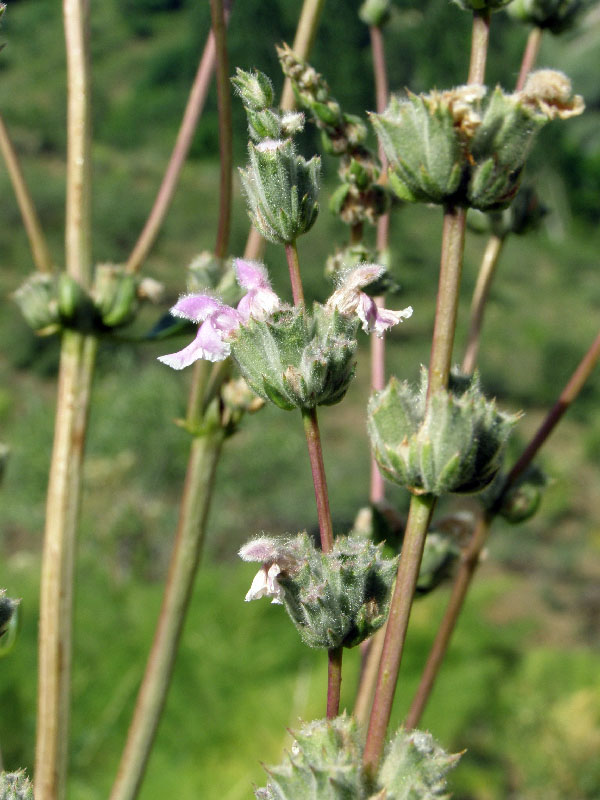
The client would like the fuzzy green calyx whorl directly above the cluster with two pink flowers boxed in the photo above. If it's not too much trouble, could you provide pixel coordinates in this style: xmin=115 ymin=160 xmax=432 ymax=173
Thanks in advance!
xmin=240 ymin=139 xmax=321 ymax=244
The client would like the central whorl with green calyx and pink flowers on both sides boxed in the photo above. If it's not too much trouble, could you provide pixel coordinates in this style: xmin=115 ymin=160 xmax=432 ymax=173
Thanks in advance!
xmin=159 ymin=259 xmax=412 ymax=410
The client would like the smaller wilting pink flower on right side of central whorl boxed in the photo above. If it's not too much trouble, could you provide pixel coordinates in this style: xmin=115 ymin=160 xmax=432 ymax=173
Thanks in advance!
xmin=327 ymin=264 xmax=412 ymax=336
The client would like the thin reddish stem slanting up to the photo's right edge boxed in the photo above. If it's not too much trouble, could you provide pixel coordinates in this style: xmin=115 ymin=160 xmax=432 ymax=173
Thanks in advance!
xmin=405 ymin=333 xmax=600 ymax=729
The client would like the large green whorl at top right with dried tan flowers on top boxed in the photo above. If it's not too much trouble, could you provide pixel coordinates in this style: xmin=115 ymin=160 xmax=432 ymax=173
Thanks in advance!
xmin=371 ymin=70 xmax=583 ymax=211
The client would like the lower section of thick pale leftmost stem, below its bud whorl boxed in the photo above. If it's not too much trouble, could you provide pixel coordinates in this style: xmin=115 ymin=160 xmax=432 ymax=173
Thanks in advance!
xmin=35 ymin=331 xmax=96 ymax=800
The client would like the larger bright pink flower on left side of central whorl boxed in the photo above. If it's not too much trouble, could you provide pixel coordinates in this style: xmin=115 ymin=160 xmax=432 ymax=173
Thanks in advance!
xmin=158 ymin=258 xmax=280 ymax=369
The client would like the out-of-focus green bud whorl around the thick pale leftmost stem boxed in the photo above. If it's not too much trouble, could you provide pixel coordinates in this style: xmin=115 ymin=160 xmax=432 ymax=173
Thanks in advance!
xmin=13 ymin=264 xmax=162 ymax=336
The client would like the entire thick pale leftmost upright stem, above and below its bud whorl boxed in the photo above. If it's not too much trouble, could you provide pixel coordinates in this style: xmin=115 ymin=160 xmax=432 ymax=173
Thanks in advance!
xmin=35 ymin=6 xmax=96 ymax=800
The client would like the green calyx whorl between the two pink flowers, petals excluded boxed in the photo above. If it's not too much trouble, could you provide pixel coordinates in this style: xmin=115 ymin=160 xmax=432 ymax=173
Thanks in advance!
xmin=231 ymin=304 xmax=359 ymax=411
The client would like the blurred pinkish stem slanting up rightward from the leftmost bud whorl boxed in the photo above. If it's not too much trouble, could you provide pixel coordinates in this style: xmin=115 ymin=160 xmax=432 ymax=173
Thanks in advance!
xmin=127 ymin=0 xmax=233 ymax=272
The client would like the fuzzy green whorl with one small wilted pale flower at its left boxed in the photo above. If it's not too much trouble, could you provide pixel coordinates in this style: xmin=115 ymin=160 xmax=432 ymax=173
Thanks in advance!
xmin=240 ymin=533 xmax=396 ymax=649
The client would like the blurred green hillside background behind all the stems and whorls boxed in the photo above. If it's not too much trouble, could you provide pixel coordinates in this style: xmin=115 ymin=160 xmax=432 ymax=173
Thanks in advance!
xmin=0 ymin=0 xmax=600 ymax=800
